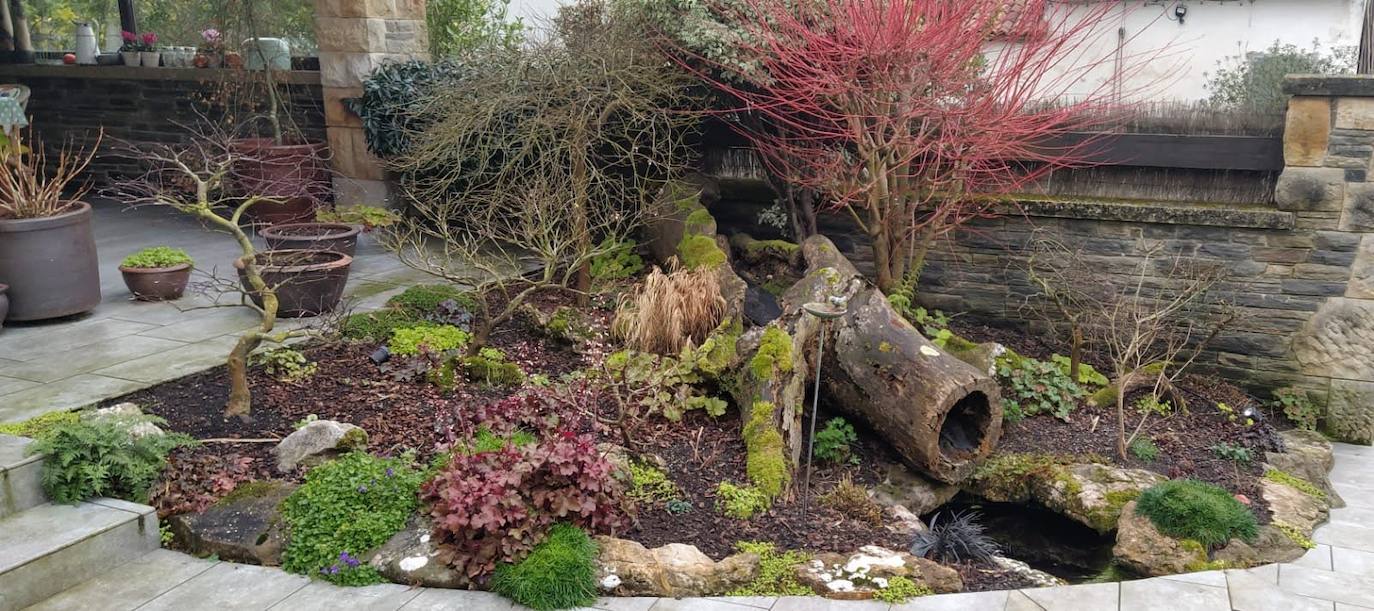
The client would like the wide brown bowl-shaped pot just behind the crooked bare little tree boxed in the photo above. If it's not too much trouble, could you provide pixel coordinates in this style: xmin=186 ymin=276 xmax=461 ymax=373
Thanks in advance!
xmin=234 ymin=250 xmax=353 ymax=319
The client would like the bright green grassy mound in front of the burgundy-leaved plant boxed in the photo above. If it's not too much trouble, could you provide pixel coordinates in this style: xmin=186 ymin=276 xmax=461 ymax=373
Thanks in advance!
xmin=492 ymin=524 xmax=598 ymax=611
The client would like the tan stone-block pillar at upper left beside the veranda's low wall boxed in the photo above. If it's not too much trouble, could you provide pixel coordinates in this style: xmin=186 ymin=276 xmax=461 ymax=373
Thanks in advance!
xmin=315 ymin=0 xmax=429 ymax=205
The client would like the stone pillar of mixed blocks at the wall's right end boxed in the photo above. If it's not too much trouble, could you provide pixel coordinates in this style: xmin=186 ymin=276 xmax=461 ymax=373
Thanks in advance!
xmin=1275 ymin=76 xmax=1374 ymax=445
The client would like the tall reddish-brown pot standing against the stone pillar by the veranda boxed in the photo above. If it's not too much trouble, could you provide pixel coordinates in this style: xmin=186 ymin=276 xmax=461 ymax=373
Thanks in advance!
xmin=231 ymin=137 xmax=330 ymax=225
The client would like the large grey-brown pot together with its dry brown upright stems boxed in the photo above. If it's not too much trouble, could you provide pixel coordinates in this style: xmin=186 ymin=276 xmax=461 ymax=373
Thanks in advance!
xmin=0 ymin=135 xmax=100 ymax=320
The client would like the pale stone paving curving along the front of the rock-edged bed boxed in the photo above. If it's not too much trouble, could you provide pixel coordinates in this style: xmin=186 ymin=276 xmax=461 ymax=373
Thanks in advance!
xmin=18 ymin=443 xmax=1374 ymax=611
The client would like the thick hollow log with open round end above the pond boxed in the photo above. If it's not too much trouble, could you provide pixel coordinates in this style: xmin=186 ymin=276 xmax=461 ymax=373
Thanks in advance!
xmin=783 ymin=236 xmax=1002 ymax=483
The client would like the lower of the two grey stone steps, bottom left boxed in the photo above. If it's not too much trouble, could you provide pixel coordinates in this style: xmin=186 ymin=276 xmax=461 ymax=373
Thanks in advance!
xmin=0 ymin=498 xmax=159 ymax=611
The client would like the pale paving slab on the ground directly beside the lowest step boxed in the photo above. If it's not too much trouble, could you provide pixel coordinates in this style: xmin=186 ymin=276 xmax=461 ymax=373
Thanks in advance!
xmin=29 ymin=549 xmax=216 ymax=611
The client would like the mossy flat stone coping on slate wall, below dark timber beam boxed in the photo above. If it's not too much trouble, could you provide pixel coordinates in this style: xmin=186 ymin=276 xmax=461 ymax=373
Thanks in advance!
xmin=996 ymin=198 xmax=1297 ymax=229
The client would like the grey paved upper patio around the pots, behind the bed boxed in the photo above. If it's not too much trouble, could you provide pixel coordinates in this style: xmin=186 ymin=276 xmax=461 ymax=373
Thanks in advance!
xmin=0 ymin=200 xmax=431 ymax=422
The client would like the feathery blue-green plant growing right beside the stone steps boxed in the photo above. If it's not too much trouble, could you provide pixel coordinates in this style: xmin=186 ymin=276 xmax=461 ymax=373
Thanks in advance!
xmin=29 ymin=416 xmax=195 ymax=504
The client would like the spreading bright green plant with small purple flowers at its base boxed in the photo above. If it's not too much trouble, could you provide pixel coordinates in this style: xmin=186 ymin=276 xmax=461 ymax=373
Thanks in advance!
xmin=282 ymin=452 xmax=423 ymax=585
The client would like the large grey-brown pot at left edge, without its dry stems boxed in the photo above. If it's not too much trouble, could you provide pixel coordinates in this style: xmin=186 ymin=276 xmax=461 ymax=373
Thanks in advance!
xmin=0 ymin=202 xmax=100 ymax=320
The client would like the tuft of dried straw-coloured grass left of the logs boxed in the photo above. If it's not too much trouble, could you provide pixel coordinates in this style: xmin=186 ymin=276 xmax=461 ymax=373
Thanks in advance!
xmin=613 ymin=264 xmax=725 ymax=356
